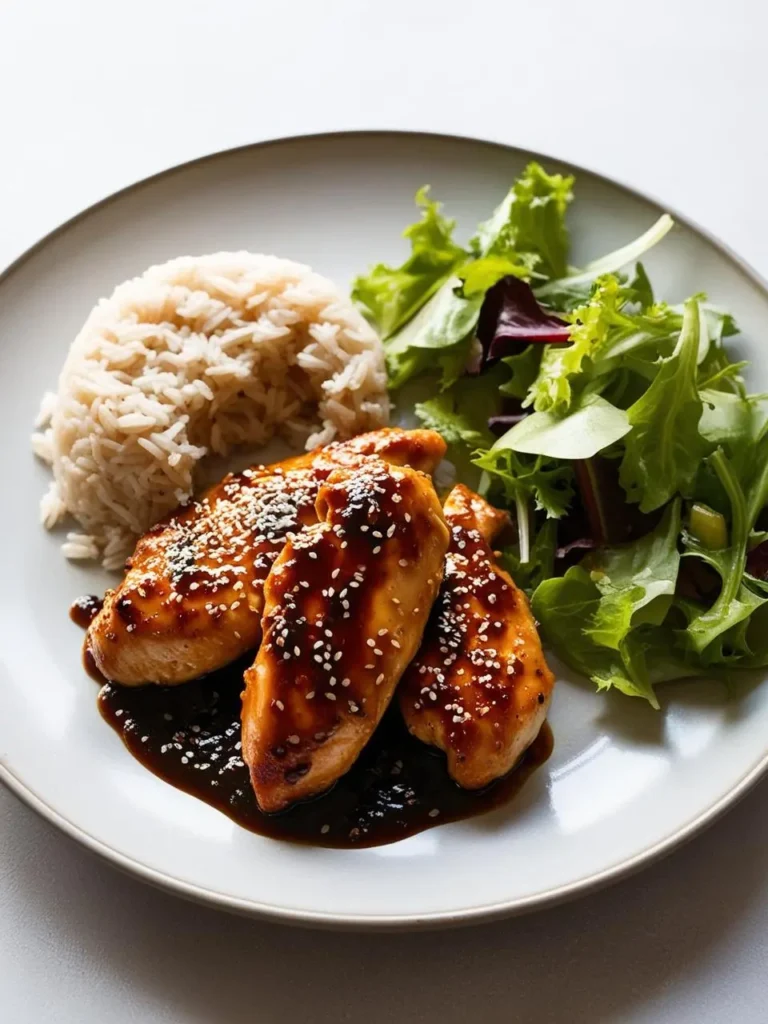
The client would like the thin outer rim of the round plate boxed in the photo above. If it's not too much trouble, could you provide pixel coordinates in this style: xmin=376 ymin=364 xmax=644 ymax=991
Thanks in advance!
xmin=0 ymin=129 xmax=768 ymax=932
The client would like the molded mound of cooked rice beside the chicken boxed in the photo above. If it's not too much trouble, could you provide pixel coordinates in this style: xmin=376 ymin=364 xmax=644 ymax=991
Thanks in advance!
xmin=32 ymin=252 xmax=389 ymax=568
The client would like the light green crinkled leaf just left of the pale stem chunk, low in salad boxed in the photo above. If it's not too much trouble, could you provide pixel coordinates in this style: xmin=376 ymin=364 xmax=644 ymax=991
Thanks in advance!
xmin=582 ymin=499 xmax=680 ymax=650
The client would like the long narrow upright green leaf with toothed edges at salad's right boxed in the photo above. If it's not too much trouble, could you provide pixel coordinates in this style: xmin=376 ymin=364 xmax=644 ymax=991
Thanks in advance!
xmin=620 ymin=299 xmax=711 ymax=512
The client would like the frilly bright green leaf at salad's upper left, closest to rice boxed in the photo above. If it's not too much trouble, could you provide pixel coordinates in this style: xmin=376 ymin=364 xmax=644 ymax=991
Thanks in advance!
xmin=352 ymin=185 xmax=468 ymax=339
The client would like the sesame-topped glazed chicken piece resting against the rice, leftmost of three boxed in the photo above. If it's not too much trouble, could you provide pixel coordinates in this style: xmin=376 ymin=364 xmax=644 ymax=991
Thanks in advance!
xmin=86 ymin=429 xmax=445 ymax=685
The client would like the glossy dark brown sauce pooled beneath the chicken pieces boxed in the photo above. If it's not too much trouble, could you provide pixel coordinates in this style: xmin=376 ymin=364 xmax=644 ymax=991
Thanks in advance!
xmin=98 ymin=658 xmax=553 ymax=848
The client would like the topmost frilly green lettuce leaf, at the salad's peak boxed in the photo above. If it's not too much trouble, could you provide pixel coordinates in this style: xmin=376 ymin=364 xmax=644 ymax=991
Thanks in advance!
xmin=469 ymin=157 xmax=573 ymax=278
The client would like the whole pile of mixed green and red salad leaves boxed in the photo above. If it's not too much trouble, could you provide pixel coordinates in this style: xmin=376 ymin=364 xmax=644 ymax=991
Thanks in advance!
xmin=352 ymin=163 xmax=768 ymax=708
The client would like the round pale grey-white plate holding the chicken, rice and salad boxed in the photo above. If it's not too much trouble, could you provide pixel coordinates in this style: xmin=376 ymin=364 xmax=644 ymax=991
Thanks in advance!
xmin=0 ymin=133 xmax=768 ymax=928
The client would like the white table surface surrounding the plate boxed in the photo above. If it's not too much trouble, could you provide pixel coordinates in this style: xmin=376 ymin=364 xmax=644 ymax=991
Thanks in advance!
xmin=0 ymin=0 xmax=768 ymax=1024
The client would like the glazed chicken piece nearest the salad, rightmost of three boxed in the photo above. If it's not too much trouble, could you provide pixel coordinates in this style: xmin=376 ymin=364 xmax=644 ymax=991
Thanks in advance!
xmin=398 ymin=484 xmax=554 ymax=790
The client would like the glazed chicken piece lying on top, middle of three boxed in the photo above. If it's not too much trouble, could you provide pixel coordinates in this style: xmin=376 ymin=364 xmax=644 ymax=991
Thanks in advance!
xmin=243 ymin=460 xmax=449 ymax=811
